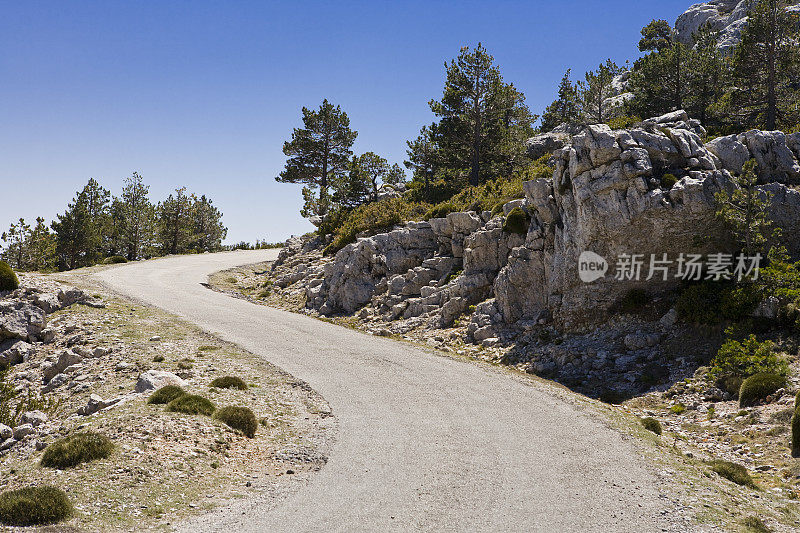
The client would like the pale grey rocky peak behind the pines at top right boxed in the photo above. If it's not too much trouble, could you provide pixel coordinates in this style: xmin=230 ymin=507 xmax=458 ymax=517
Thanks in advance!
xmin=675 ymin=0 xmax=800 ymax=53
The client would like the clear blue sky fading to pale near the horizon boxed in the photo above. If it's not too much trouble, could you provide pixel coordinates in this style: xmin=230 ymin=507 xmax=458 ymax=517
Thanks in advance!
xmin=0 ymin=0 xmax=692 ymax=242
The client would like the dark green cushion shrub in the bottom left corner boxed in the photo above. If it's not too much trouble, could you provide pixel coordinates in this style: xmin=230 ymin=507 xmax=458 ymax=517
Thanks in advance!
xmin=0 ymin=487 xmax=72 ymax=526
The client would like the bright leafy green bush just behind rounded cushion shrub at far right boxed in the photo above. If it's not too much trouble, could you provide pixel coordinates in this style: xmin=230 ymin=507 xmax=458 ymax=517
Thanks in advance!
xmin=709 ymin=330 xmax=789 ymax=378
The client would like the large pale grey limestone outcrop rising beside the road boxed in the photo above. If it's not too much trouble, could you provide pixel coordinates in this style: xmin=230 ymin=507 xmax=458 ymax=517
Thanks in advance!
xmin=273 ymin=111 xmax=800 ymax=334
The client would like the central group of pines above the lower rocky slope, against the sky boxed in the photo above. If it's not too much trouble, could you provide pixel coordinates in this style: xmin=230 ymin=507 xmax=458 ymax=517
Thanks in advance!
xmin=276 ymin=44 xmax=537 ymax=219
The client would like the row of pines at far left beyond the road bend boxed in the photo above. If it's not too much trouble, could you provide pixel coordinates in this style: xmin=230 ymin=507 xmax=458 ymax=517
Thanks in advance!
xmin=0 ymin=172 xmax=227 ymax=270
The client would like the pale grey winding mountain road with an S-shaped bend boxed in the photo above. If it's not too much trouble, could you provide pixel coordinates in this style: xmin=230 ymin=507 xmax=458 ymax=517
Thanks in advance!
xmin=95 ymin=250 xmax=667 ymax=533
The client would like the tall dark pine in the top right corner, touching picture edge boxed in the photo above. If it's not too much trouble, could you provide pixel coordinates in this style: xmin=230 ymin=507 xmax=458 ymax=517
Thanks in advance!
xmin=727 ymin=0 xmax=800 ymax=130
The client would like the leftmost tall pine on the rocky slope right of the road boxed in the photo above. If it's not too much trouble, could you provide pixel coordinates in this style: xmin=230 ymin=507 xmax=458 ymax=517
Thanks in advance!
xmin=275 ymin=100 xmax=358 ymax=218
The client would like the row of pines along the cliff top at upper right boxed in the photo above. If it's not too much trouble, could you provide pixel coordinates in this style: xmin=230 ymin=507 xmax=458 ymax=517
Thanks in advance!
xmin=541 ymin=0 xmax=800 ymax=134
